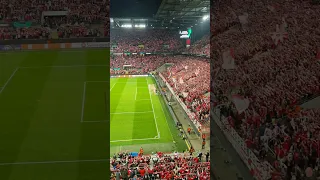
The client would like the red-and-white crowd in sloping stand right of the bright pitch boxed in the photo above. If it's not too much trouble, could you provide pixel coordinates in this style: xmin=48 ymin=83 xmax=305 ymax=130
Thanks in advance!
xmin=163 ymin=56 xmax=210 ymax=124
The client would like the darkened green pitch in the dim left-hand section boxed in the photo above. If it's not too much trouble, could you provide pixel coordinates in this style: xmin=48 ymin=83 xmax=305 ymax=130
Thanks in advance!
xmin=0 ymin=49 xmax=110 ymax=180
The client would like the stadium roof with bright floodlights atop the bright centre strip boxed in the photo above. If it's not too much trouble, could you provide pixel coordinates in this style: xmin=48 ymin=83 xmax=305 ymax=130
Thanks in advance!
xmin=111 ymin=0 xmax=210 ymax=29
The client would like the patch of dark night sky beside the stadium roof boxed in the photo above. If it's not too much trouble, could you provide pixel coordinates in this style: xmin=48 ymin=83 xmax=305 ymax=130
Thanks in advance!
xmin=110 ymin=0 xmax=161 ymax=17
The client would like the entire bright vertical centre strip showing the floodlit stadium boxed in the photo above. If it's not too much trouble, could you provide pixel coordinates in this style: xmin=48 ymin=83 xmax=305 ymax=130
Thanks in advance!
xmin=110 ymin=0 xmax=210 ymax=179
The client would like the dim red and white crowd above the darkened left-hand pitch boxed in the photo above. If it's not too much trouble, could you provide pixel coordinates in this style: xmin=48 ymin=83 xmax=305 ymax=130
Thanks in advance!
xmin=0 ymin=0 xmax=110 ymax=40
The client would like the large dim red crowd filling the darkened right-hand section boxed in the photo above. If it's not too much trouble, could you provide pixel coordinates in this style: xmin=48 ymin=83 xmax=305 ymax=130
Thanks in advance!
xmin=211 ymin=0 xmax=320 ymax=180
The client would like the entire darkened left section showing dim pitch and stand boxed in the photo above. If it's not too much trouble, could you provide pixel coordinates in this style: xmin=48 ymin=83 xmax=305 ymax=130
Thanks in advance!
xmin=0 ymin=0 xmax=110 ymax=180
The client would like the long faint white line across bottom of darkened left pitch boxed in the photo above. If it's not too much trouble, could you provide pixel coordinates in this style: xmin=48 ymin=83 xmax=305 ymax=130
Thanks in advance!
xmin=0 ymin=159 xmax=109 ymax=166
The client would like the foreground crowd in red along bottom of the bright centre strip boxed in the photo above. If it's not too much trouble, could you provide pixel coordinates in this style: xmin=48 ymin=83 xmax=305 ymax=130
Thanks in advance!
xmin=110 ymin=152 xmax=210 ymax=180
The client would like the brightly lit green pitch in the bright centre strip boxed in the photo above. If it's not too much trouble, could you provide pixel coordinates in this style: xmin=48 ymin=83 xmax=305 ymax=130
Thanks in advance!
xmin=110 ymin=77 xmax=187 ymax=154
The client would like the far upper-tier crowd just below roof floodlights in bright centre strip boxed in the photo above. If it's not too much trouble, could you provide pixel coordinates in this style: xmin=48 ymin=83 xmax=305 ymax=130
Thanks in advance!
xmin=111 ymin=28 xmax=182 ymax=53
